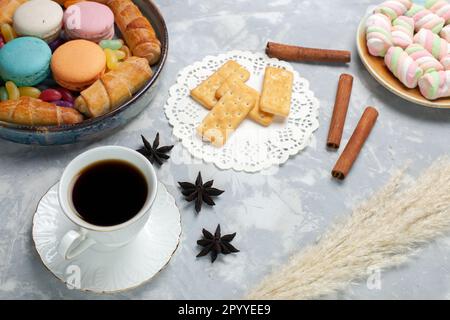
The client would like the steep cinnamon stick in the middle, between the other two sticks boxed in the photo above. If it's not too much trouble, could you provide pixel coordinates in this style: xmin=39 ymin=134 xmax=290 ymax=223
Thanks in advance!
xmin=327 ymin=74 xmax=353 ymax=149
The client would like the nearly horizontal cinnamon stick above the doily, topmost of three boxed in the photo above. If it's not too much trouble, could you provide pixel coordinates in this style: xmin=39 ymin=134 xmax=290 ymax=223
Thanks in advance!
xmin=266 ymin=42 xmax=352 ymax=63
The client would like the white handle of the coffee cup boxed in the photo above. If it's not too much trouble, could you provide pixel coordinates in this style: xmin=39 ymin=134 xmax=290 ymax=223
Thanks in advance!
xmin=58 ymin=229 xmax=95 ymax=260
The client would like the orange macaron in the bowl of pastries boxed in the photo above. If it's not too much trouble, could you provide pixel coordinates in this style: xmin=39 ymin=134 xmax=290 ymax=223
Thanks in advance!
xmin=51 ymin=39 xmax=106 ymax=91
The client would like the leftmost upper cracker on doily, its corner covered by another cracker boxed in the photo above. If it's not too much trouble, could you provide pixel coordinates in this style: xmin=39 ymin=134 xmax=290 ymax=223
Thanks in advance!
xmin=191 ymin=60 xmax=250 ymax=109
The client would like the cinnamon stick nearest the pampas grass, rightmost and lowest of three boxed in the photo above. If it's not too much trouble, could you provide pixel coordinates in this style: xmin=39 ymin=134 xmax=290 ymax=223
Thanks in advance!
xmin=331 ymin=107 xmax=378 ymax=180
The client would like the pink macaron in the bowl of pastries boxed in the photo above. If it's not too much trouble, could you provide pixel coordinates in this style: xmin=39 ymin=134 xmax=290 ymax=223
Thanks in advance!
xmin=63 ymin=1 xmax=114 ymax=43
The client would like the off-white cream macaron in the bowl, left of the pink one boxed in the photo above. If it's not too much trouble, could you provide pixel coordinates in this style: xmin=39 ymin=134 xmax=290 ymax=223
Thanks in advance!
xmin=13 ymin=0 xmax=63 ymax=42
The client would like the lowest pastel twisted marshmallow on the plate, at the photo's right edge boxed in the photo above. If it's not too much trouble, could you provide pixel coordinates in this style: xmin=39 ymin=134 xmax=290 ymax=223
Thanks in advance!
xmin=419 ymin=71 xmax=450 ymax=100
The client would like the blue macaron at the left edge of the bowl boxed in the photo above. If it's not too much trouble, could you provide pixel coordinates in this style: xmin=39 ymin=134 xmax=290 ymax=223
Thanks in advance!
xmin=0 ymin=37 xmax=52 ymax=87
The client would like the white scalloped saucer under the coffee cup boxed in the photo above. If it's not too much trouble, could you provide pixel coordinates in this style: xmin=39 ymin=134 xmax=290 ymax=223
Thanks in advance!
xmin=33 ymin=183 xmax=181 ymax=293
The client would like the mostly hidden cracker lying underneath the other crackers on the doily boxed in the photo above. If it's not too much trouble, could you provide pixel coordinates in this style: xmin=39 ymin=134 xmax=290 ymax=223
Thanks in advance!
xmin=216 ymin=78 xmax=274 ymax=127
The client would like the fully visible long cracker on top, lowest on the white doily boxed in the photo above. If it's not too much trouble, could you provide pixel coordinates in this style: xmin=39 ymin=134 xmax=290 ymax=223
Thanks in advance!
xmin=197 ymin=87 xmax=256 ymax=147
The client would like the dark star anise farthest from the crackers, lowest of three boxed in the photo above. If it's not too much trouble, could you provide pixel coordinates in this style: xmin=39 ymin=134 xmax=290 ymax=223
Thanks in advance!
xmin=197 ymin=224 xmax=239 ymax=263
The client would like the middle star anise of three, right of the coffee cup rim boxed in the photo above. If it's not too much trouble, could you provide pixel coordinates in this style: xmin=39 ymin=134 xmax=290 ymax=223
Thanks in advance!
xmin=178 ymin=172 xmax=224 ymax=213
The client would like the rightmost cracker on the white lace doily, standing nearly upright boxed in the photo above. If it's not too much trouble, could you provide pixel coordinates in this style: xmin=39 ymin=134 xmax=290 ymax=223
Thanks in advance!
xmin=259 ymin=67 xmax=294 ymax=117
